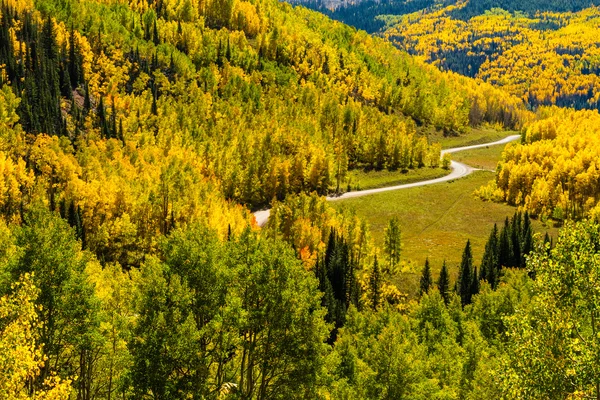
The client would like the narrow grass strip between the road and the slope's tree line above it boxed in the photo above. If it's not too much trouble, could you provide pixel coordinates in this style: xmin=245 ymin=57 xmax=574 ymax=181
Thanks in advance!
xmin=349 ymin=168 xmax=450 ymax=190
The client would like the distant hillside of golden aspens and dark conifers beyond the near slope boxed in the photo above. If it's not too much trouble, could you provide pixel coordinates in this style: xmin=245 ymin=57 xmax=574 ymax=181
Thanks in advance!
xmin=384 ymin=2 xmax=600 ymax=109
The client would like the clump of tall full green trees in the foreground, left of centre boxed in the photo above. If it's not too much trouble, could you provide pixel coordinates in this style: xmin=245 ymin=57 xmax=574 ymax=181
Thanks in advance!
xmin=130 ymin=228 xmax=328 ymax=398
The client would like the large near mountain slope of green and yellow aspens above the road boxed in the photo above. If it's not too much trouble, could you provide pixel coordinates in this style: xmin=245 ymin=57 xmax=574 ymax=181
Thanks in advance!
xmin=0 ymin=0 xmax=525 ymax=247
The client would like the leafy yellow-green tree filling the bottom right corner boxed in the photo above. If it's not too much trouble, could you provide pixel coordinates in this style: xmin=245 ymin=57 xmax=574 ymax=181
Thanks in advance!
xmin=503 ymin=222 xmax=600 ymax=399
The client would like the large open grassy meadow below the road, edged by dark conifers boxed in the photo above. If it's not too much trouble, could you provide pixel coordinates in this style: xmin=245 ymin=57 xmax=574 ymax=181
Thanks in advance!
xmin=333 ymin=170 xmax=555 ymax=294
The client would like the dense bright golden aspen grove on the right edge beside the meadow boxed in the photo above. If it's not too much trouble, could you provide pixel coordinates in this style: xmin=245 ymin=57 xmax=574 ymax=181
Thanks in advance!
xmin=480 ymin=107 xmax=600 ymax=221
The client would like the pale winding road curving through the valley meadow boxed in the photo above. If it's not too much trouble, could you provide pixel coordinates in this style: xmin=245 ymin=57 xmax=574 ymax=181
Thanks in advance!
xmin=254 ymin=135 xmax=521 ymax=227
